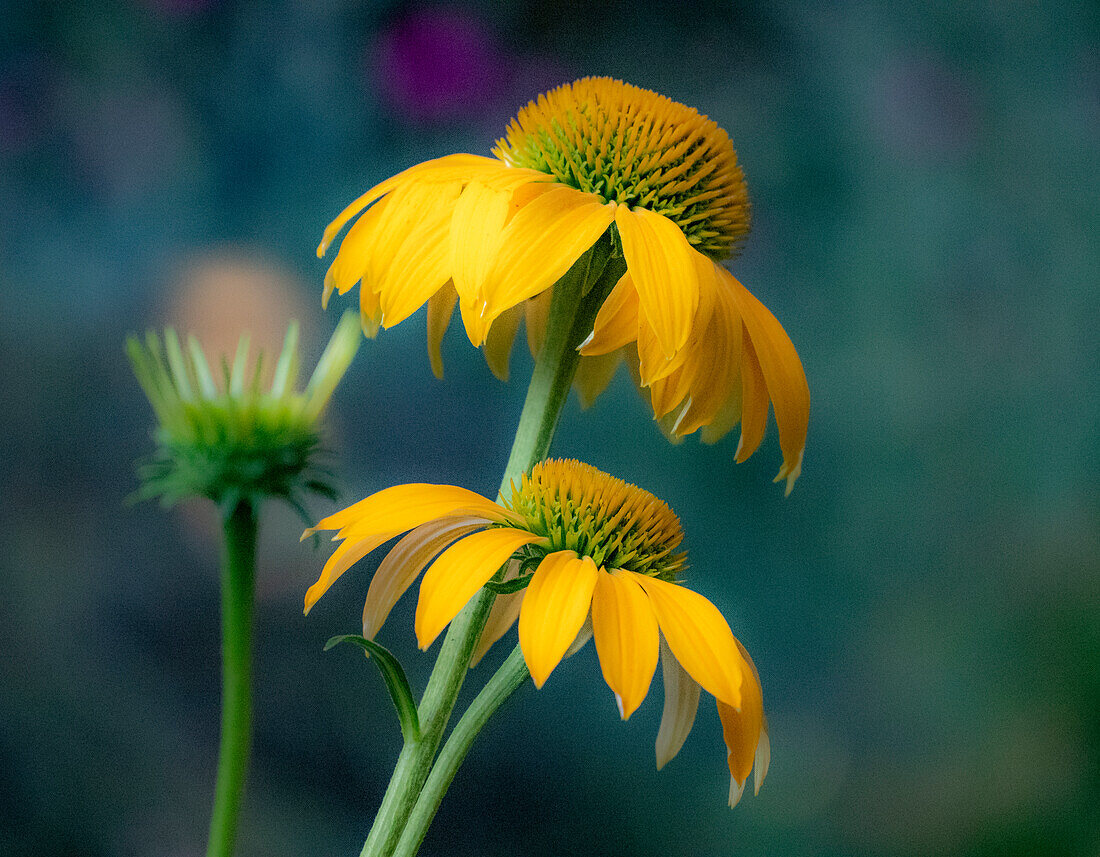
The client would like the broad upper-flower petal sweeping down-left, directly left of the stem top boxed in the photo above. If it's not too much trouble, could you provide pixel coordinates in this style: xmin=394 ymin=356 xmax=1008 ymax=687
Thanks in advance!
xmin=471 ymin=186 xmax=615 ymax=345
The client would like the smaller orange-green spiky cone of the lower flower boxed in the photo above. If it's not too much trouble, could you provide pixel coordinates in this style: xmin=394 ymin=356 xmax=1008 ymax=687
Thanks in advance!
xmin=505 ymin=460 xmax=686 ymax=581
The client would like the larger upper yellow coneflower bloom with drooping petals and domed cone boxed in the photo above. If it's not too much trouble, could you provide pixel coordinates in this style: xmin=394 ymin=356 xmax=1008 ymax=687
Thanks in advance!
xmin=318 ymin=78 xmax=810 ymax=491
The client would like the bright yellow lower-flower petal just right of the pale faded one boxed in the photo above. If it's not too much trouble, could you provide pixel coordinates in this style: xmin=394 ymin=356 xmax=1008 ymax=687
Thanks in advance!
xmin=415 ymin=527 xmax=540 ymax=649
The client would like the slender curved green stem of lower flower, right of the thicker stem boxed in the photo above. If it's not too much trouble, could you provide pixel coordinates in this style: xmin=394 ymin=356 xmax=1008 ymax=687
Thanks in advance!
xmin=393 ymin=646 xmax=530 ymax=857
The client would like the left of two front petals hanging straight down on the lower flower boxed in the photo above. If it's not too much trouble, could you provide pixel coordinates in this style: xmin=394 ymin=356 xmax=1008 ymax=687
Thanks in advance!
xmin=519 ymin=550 xmax=598 ymax=688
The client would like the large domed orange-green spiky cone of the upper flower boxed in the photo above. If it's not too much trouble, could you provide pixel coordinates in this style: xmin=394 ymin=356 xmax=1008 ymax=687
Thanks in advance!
xmin=493 ymin=77 xmax=749 ymax=262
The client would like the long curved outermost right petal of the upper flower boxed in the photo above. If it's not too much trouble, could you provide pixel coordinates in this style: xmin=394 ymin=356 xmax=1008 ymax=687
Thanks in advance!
xmin=721 ymin=268 xmax=810 ymax=492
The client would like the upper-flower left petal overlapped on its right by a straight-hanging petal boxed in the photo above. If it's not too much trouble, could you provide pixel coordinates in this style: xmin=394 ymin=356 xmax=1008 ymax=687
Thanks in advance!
xmin=378 ymin=182 xmax=460 ymax=328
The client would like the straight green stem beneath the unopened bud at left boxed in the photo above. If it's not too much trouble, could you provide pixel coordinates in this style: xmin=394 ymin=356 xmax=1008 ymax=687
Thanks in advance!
xmin=207 ymin=499 xmax=256 ymax=857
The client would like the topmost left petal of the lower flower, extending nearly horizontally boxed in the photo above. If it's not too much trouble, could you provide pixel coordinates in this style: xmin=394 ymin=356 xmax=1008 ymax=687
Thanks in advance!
xmin=301 ymin=482 xmax=518 ymax=539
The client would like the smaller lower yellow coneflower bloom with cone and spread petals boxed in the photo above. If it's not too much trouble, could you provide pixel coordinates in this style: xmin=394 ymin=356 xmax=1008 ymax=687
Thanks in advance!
xmin=306 ymin=460 xmax=769 ymax=805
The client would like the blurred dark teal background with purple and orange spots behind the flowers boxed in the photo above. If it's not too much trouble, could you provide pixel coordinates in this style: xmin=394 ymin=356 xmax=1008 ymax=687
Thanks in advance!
xmin=0 ymin=0 xmax=1100 ymax=857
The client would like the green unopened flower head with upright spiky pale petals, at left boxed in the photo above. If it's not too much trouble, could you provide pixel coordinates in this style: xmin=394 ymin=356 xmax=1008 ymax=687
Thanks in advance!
xmin=127 ymin=314 xmax=361 ymax=510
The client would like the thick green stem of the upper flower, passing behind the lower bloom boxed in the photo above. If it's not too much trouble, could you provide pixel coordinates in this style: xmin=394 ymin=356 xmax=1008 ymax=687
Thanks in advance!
xmin=360 ymin=239 xmax=623 ymax=857
